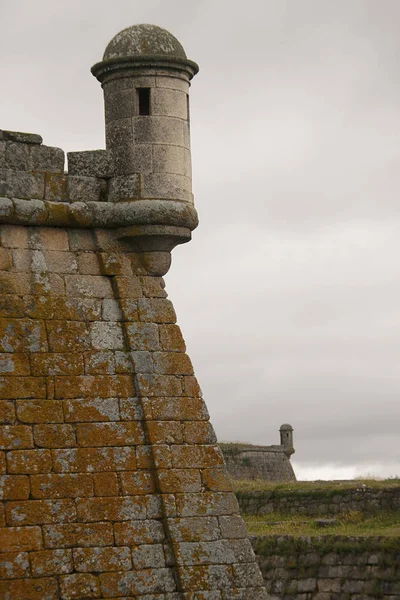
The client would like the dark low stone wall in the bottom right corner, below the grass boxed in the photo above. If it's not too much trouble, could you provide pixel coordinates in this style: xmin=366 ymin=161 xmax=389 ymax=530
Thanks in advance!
xmin=252 ymin=536 xmax=400 ymax=600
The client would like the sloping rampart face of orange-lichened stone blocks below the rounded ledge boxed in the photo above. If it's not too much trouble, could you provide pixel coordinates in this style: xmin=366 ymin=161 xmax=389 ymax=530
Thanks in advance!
xmin=0 ymin=225 xmax=264 ymax=600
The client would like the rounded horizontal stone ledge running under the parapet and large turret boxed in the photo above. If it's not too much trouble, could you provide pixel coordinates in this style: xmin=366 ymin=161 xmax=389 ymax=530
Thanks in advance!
xmin=0 ymin=198 xmax=198 ymax=231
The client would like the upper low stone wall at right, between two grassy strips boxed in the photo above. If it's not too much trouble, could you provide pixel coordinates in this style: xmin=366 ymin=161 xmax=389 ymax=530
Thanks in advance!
xmin=236 ymin=482 xmax=400 ymax=515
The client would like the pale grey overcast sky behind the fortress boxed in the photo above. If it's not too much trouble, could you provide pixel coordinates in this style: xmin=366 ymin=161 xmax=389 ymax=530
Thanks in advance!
xmin=0 ymin=0 xmax=400 ymax=478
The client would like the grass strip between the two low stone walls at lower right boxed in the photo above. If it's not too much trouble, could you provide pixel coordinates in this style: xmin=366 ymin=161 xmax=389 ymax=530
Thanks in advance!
xmin=243 ymin=511 xmax=400 ymax=537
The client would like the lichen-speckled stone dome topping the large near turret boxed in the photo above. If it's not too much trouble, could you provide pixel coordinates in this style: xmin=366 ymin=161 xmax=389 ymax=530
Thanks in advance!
xmin=103 ymin=24 xmax=186 ymax=60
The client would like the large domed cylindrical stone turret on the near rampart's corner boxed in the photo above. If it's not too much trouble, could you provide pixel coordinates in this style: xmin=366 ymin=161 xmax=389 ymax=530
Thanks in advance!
xmin=92 ymin=25 xmax=198 ymax=275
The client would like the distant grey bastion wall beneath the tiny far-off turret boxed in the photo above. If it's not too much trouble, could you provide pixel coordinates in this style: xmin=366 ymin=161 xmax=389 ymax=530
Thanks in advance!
xmin=219 ymin=444 xmax=296 ymax=481
